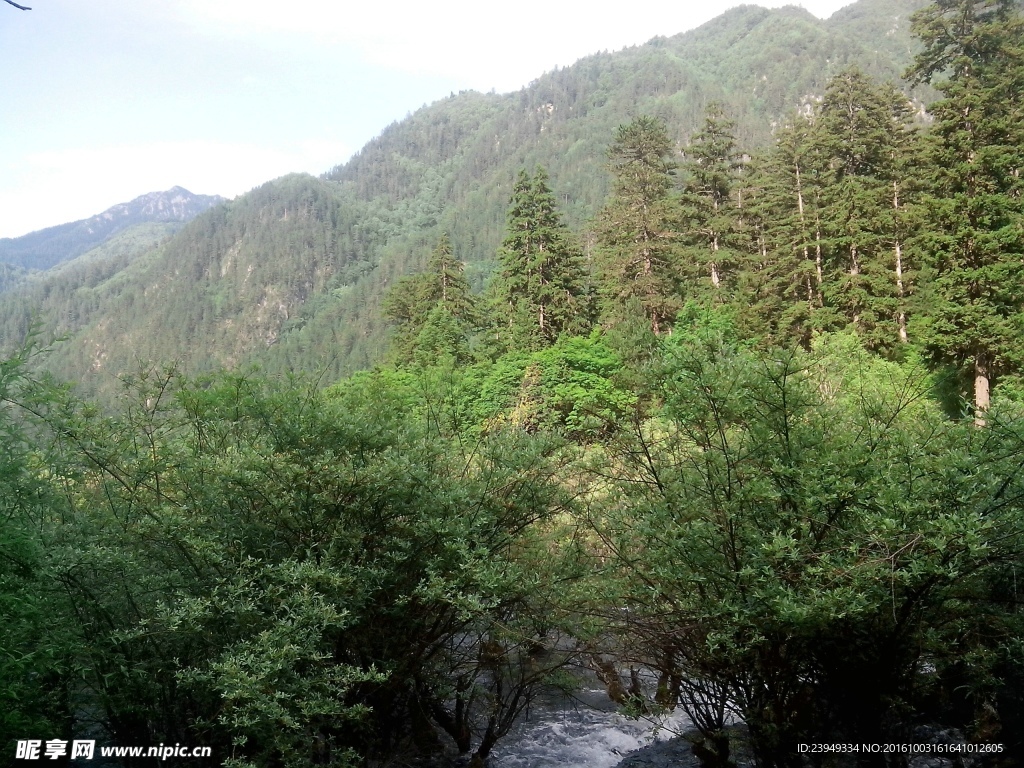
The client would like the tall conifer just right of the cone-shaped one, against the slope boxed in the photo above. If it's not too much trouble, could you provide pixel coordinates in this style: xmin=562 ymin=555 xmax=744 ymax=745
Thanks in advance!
xmin=598 ymin=117 xmax=680 ymax=334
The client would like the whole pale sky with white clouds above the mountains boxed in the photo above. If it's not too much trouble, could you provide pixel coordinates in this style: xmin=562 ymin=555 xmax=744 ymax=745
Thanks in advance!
xmin=0 ymin=0 xmax=850 ymax=238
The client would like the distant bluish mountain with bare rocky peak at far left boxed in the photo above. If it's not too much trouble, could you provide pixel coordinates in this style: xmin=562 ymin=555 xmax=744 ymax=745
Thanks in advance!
xmin=0 ymin=186 xmax=224 ymax=269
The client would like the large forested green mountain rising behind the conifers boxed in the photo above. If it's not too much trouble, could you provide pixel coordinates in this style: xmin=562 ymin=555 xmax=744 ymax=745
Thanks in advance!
xmin=0 ymin=0 xmax=931 ymax=397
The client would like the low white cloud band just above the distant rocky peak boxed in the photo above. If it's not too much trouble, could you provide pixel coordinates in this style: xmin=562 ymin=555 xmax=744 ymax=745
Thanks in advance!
xmin=0 ymin=140 xmax=352 ymax=238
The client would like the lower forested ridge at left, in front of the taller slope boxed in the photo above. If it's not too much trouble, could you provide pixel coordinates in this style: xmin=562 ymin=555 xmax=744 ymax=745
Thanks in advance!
xmin=4 ymin=175 xmax=366 ymax=387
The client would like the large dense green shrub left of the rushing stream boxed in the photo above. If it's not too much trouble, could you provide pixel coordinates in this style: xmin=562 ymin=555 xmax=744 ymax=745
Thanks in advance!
xmin=14 ymin=364 xmax=567 ymax=767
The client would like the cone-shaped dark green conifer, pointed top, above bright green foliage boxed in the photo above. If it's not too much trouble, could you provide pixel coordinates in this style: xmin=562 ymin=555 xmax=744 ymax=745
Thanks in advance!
xmin=492 ymin=167 xmax=593 ymax=349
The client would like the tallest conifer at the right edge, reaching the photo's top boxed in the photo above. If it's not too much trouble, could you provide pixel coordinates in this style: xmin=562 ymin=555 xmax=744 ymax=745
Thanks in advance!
xmin=908 ymin=0 xmax=1024 ymax=424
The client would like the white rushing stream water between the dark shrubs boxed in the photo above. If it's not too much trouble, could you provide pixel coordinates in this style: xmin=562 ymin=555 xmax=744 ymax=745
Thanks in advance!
xmin=489 ymin=685 xmax=688 ymax=768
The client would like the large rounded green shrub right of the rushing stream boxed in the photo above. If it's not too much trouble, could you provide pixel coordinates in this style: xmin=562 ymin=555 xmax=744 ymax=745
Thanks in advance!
xmin=591 ymin=339 xmax=1022 ymax=766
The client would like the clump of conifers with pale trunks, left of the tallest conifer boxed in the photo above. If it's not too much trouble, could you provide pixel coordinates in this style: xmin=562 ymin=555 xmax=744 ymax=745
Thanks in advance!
xmin=739 ymin=68 xmax=921 ymax=355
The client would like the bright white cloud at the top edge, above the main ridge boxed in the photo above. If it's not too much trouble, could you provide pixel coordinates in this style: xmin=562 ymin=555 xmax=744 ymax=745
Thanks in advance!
xmin=180 ymin=0 xmax=852 ymax=91
